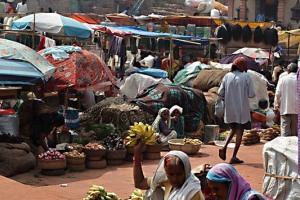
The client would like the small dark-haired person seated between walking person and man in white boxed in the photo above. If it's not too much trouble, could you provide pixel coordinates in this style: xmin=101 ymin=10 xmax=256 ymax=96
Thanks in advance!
xmin=251 ymin=99 xmax=268 ymax=129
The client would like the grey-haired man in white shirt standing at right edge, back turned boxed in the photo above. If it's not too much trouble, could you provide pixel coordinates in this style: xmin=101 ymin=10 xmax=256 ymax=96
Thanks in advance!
xmin=274 ymin=63 xmax=298 ymax=136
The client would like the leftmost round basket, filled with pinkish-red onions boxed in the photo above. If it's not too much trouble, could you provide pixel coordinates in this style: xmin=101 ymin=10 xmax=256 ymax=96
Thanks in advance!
xmin=37 ymin=150 xmax=67 ymax=176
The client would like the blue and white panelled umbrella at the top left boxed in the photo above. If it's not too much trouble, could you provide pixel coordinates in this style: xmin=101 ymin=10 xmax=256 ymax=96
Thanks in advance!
xmin=12 ymin=13 xmax=92 ymax=39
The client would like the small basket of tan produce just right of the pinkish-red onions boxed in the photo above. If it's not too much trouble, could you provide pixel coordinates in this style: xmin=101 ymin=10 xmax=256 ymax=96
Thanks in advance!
xmin=64 ymin=150 xmax=86 ymax=171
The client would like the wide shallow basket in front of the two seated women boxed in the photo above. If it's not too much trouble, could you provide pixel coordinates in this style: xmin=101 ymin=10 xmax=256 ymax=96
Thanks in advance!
xmin=168 ymin=138 xmax=202 ymax=155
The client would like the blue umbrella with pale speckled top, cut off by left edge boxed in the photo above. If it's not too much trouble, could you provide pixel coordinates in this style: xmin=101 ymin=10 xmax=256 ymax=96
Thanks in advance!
xmin=0 ymin=39 xmax=55 ymax=84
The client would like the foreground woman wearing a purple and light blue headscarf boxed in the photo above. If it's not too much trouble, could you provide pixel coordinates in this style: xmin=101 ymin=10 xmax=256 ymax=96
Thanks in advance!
xmin=206 ymin=163 xmax=266 ymax=200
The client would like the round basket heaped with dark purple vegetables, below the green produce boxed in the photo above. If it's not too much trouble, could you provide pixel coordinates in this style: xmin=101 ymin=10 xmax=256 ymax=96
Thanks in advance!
xmin=103 ymin=133 xmax=126 ymax=165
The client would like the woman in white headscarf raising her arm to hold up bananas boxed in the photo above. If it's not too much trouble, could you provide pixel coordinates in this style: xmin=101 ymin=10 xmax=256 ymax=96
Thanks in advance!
xmin=133 ymin=141 xmax=204 ymax=200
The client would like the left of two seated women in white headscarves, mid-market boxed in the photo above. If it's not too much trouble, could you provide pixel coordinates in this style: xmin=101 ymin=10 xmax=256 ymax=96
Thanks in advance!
xmin=152 ymin=108 xmax=177 ymax=146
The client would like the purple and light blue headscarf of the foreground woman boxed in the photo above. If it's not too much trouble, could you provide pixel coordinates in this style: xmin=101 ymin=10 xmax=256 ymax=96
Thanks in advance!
xmin=206 ymin=163 xmax=251 ymax=200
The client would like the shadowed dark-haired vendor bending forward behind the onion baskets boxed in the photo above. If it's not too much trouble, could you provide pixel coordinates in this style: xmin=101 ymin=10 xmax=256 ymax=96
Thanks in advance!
xmin=30 ymin=112 xmax=65 ymax=154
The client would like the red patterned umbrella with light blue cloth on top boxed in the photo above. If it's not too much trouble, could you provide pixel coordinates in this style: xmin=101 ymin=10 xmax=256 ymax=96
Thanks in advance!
xmin=39 ymin=46 xmax=116 ymax=89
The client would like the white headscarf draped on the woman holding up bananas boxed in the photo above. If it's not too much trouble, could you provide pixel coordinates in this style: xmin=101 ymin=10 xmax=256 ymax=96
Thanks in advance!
xmin=147 ymin=151 xmax=201 ymax=200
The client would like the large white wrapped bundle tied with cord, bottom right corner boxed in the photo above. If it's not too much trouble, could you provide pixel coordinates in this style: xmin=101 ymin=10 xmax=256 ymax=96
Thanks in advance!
xmin=262 ymin=136 xmax=300 ymax=200
